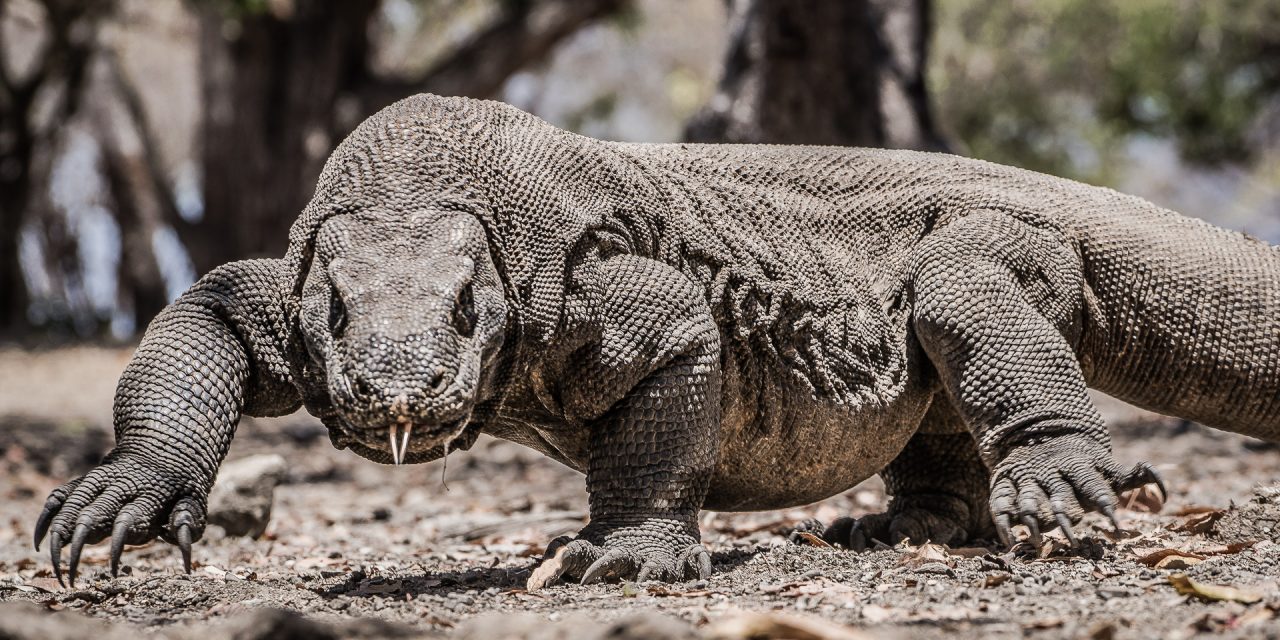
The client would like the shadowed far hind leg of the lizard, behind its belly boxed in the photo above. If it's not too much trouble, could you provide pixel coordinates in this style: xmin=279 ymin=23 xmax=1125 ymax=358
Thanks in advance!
xmin=823 ymin=393 xmax=995 ymax=552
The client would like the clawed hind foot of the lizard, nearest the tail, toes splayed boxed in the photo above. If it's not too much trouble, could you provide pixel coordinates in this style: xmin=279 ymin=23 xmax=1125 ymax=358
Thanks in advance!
xmin=991 ymin=436 xmax=1169 ymax=547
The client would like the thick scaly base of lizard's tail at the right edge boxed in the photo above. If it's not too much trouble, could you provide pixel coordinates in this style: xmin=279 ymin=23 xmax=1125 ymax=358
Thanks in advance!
xmin=1070 ymin=191 xmax=1280 ymax=442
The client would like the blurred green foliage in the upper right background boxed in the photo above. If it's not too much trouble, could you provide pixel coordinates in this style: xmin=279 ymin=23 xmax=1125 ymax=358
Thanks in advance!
xmin=931 ymin=0 xmax=1280 ymax=182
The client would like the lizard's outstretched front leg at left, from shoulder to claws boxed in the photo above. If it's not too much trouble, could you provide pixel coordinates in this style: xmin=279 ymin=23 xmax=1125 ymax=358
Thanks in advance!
xmin=35 ymin=260 xmax=301 ymax=585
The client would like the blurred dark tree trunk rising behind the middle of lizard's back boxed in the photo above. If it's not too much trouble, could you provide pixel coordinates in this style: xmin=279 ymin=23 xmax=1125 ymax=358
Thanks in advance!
xmin=686 ymin=0 xmax=946 ymax=151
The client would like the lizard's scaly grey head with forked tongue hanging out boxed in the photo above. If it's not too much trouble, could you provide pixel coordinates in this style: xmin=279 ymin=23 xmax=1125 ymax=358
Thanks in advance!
xmin=300 ymin=211 xmax=507 ymax=465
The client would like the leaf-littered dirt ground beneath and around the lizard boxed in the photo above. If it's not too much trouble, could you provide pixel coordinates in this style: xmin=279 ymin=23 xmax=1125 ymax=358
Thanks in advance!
xmin=0 ymin=348 xmax=1280 ymax=640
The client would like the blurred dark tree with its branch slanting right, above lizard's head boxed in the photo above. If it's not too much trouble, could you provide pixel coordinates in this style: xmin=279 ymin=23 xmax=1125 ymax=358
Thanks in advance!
xmin=178 ymin=0 xmax=626 ymax=273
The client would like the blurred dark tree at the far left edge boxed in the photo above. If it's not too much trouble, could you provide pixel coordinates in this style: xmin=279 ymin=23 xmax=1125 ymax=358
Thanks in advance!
xmin=0 ymin=0 xmax=113 ymax=334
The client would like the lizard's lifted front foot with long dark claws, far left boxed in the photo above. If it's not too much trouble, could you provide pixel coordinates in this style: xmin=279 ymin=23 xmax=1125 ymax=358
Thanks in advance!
xmin=35 ymin=457 xmax=205 ymax=586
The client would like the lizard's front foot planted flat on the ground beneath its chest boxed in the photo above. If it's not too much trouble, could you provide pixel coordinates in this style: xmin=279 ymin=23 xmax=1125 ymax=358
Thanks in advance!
xmin=526 ymin=518 xmax=712 ymax=591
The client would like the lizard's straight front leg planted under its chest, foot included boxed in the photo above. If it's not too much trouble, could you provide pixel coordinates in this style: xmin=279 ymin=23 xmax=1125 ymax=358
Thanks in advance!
xmin=530 ymin=256 xmax=721 ymax=589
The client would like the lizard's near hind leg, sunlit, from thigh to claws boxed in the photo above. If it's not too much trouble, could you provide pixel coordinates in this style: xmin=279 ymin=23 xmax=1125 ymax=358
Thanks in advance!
xmin=910 ymin=214 xmax=1160 ymax=543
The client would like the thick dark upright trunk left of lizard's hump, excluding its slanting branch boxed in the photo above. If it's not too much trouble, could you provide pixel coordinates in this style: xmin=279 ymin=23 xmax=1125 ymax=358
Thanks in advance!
xmin=189 ymin=0 xmax=378 ymax=274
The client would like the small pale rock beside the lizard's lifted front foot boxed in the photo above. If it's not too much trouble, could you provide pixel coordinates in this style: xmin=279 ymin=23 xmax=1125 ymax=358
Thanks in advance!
xmin=209 ymin=453 xmax=287 ymax=538
